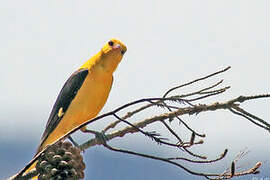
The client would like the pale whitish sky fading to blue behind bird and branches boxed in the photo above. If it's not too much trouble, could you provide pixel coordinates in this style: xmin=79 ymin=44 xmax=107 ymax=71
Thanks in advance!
xmin=0 ymin=0 xmax=270 ymax=180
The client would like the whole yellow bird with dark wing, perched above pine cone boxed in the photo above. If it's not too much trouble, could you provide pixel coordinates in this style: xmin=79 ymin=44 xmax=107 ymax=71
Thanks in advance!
xmin=27 ymin=39 xmax=127 ymax=174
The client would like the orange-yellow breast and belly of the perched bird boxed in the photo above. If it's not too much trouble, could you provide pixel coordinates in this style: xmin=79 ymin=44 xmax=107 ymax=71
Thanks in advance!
xmin=58 ymin=70 xmax=113 ymax=131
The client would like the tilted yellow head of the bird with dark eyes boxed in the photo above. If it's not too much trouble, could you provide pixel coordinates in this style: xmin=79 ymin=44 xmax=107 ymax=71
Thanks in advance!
xmin=100 ymin=39 xmax=127 ymax=72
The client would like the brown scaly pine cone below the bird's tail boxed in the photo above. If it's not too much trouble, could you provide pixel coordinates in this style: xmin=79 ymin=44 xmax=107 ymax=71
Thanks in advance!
xmin=36 ymin=142 xmax=85 ymax=180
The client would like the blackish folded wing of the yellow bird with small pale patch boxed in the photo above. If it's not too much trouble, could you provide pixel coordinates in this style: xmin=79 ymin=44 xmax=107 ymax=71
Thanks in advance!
xmin=39 ymin=69 xmax=88 ymax=151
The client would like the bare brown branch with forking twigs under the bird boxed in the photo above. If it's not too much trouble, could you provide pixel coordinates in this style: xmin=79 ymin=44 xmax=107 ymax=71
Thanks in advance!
xmin=11 ymin=67 xmax=270 ymax=179
